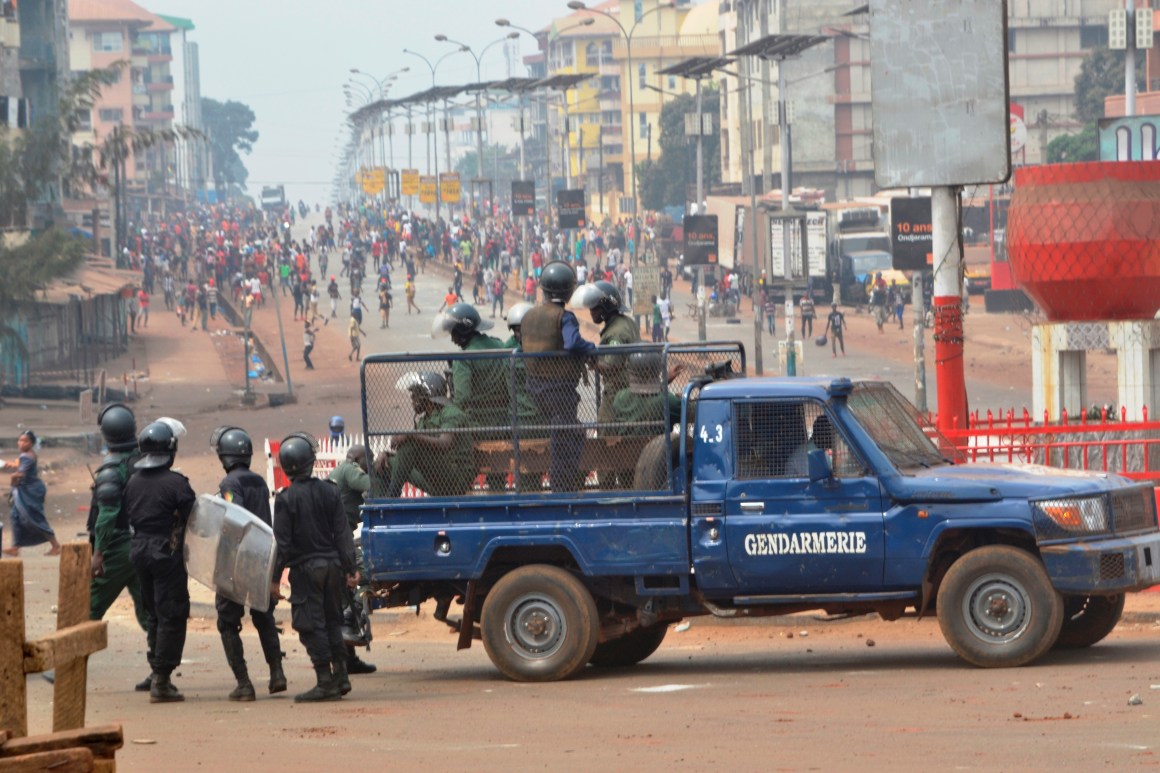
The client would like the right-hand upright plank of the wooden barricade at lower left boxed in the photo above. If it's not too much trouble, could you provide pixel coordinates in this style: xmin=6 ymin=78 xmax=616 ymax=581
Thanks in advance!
xmin=52 ymin=541 xmax=92 ymax=731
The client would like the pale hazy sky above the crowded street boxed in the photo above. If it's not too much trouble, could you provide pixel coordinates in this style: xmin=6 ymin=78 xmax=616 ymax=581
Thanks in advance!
xmin=155 ymin=0 xmax=571 ymax=204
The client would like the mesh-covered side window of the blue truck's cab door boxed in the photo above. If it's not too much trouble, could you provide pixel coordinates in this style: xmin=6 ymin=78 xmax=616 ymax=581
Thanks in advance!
xmin=734 ymin=400 xmax=865 ymax=481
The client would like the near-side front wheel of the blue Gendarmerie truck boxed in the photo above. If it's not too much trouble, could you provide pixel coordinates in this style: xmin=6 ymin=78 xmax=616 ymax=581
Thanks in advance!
xmin=937 ymin=546 xmax=1064 ymax=669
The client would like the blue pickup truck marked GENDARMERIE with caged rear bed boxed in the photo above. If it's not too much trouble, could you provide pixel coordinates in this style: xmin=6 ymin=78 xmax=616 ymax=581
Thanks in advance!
xmin=361 ymin=344 xmax=1160 ymax=681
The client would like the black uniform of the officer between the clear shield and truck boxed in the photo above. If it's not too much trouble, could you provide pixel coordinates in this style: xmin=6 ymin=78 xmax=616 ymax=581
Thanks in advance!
xmin=274 ymin=478 xmax=355 ymax=669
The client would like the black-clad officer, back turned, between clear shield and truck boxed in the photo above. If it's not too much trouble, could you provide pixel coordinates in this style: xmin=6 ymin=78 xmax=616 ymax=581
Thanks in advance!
xmin=270 ymin=433 xmax=355 ymax=702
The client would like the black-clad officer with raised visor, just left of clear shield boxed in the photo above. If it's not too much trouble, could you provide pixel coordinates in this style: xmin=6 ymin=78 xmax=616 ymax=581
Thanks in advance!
xmin=124 ymin=421 xmax=197 ymax=703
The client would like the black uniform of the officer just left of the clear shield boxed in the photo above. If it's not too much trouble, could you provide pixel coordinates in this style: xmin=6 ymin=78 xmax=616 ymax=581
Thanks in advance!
xmin=123 ymin=468 xmax=197 ymax=677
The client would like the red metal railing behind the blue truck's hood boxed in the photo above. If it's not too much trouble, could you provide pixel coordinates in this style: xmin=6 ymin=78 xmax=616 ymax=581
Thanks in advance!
xmin=943 ymin=409 xmax=1160 ymax=482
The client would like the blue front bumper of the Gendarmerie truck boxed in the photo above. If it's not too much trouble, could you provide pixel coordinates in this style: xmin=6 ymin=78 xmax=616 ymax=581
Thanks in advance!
xmin=1039 ymin=532 xmax=1160 ymax=594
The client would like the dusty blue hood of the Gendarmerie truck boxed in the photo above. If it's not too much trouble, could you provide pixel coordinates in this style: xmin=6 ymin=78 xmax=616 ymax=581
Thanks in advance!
xmin=886 ymin=463 xmax=1132 ymax=501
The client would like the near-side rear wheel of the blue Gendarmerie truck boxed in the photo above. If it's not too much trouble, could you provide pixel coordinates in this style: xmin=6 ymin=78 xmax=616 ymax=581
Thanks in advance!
xmin=480 ymin=564 xmax=600 ymax=681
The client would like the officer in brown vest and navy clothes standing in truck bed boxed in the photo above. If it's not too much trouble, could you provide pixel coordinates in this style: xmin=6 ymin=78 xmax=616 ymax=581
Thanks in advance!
xmin=520 ymin=260 xmax=596 ymax=491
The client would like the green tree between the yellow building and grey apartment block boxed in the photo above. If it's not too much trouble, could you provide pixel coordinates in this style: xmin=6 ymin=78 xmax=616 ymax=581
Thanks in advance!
xmin=637 ymin=87 xmax=722 ymax=210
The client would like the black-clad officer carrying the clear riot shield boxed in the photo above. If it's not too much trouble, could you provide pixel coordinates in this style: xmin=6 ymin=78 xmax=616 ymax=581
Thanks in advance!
xmin=210 ymin=426 xmax=287 ymax=701
